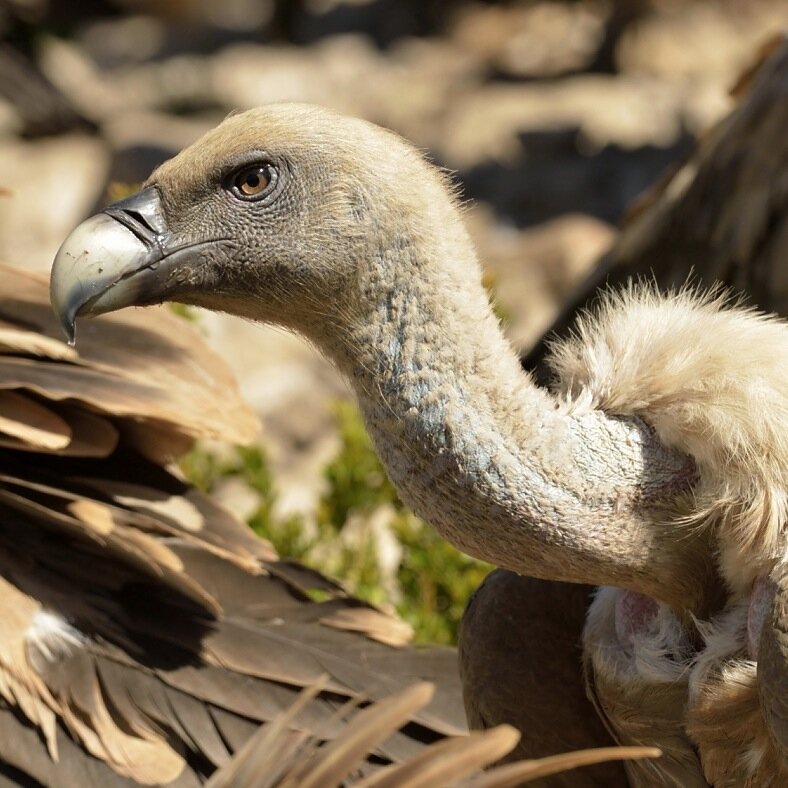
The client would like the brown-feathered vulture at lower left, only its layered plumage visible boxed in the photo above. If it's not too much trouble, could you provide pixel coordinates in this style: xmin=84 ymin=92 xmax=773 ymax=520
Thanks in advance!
xmin=0 ymin=266 xmax=653 ymax=788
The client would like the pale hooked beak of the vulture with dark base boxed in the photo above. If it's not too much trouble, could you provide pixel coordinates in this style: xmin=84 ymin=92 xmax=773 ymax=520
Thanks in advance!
xmin=49 ymin=186 xmax=189 ymax=345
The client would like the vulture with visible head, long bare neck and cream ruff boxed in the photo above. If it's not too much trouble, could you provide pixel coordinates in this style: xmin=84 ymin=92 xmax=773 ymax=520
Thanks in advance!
xmin=51 ymin=104 xmax=788 ymax=788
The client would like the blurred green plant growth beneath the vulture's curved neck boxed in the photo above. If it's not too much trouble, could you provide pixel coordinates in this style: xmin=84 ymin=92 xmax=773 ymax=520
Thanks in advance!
xmin=181 ymin=402 xmax=490 ymax=643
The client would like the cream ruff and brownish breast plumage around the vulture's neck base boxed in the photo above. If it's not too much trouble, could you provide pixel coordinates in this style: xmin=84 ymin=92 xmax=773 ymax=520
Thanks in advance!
xmin=568 ymin=286 xmax=788 ymax=786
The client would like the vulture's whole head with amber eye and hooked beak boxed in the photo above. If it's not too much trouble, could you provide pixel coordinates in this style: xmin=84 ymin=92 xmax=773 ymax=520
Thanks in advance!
xmin=52 ymin=104 xmax=456 ymax=352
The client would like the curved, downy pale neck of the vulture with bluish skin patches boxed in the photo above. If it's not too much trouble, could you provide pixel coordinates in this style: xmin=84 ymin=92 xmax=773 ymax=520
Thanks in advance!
xmin=310 ymin=208 xmax=706 ymax=610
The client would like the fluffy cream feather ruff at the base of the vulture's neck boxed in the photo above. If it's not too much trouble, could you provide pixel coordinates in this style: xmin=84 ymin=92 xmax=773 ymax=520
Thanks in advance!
xmin=551 ymin=285 xmax=788 ymax=595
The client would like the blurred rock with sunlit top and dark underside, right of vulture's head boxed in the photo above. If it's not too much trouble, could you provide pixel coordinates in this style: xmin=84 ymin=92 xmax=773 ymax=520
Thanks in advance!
xmin=450 ymin=78 xmax=692 ymax=227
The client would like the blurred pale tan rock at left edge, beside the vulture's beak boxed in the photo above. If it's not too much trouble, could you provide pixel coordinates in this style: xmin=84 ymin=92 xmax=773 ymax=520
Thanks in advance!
xmin=0 ymin=135 xmax=109 ymax=271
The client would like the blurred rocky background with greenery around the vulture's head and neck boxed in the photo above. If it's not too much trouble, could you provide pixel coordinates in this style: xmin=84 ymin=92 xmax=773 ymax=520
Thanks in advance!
xmin=0 ymin=0 xmax=788 ymax=642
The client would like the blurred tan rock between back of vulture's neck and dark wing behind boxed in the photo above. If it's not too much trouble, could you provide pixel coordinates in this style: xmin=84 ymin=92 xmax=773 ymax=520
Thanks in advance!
xmin=467 ymin=205 xmax=616 ymax=351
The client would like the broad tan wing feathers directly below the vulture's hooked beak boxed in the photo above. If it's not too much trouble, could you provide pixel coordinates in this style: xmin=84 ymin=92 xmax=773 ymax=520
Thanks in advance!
xmin=0 ymin=266 xmax=258 ymax=450
